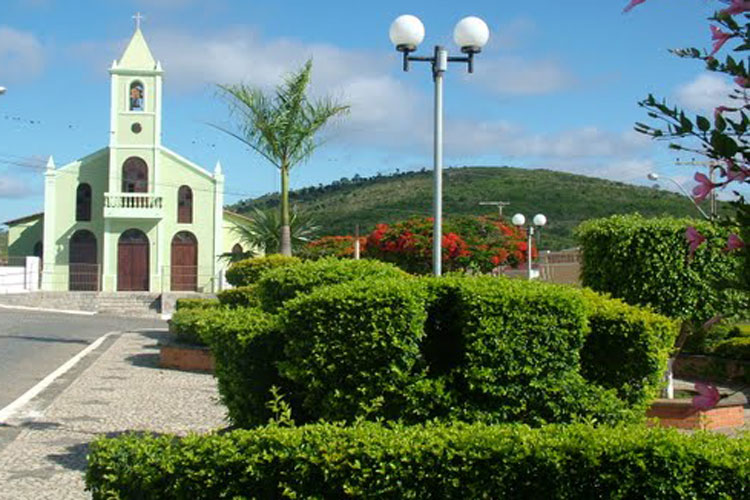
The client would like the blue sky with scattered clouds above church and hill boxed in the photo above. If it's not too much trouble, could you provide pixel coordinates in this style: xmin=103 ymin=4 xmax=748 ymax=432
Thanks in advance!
xmin=0 ymin=0 xmax=744 ymax=221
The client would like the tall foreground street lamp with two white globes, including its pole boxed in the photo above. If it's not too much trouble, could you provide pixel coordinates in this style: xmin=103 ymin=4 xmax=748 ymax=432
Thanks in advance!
xmin=389 ymin=14 xmax=490 ymax=276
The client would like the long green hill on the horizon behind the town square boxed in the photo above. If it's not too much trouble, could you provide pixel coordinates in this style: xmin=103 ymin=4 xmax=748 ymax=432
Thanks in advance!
xmin=231 ymin=167 xmax=720 ymax=249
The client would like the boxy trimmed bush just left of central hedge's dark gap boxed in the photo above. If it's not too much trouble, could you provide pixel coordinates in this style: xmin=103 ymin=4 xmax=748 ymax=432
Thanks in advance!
xmin=279 ymin=279 xmax=426 ymax=421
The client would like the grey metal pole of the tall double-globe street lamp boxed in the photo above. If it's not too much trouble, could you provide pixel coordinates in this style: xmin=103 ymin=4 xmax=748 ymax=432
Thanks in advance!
xmin=432 ymin=46 xmax=448 ymax=276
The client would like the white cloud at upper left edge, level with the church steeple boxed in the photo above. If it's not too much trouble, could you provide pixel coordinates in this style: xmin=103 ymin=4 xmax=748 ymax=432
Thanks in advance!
xmin=0 ymin=26 xmax=44 ymax=82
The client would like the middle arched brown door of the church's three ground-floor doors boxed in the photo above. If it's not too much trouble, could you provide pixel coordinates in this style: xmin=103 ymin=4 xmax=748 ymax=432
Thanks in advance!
xmin=117 ymin=229 xmax=149 ymax=292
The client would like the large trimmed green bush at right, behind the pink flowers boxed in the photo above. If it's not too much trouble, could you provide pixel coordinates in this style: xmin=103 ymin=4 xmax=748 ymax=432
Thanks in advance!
xmin=576 ymin=215 xmax=750 ymax=324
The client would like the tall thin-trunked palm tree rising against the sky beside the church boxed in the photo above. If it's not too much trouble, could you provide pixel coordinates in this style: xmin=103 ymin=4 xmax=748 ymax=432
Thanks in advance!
xmin=217 ymin=60 xmax=349 ymax=255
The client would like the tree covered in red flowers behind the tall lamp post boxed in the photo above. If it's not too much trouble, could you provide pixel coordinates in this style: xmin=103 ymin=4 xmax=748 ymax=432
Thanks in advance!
xmin=364 ymin=217 xmax=536 ymax=274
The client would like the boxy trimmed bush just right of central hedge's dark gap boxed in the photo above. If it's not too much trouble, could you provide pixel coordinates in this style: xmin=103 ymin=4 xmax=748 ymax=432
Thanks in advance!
xmin=424 ymin=278 xmax=633 ymax=425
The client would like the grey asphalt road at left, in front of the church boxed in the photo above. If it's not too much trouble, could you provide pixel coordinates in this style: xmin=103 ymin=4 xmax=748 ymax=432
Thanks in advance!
xmin=0 ymin=309 xmax=166 ymax=409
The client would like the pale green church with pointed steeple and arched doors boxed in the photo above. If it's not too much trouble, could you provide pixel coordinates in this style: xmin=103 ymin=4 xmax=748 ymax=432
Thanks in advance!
xmin=6 ymin=28 xmax=243 ymax=292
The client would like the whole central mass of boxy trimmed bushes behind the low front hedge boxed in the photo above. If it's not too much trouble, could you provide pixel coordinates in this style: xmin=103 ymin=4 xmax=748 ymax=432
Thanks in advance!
xmin=207 ymin=272 xmax=676 ymax=427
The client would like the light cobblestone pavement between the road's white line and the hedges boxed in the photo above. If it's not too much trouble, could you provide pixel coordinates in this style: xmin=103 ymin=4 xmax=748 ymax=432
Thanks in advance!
xmin=0 ymin=333 xmax=226 ymax=500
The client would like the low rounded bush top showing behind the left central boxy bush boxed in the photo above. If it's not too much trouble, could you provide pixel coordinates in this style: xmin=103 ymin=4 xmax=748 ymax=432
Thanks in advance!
xmin=258 ymin=258 xmax=409 ymax=312
